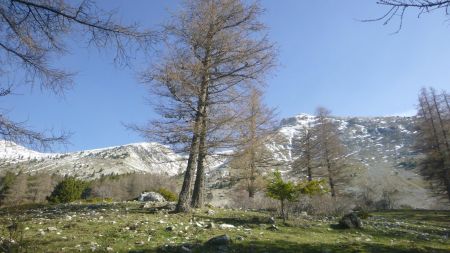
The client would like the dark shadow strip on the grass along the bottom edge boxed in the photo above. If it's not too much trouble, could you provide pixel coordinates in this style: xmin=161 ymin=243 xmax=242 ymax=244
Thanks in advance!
xmin=149 ymin=240 xmax=449 ymax=253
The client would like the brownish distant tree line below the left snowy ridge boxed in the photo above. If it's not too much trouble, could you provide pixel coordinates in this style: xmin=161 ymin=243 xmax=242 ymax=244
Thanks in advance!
xmin=0 ymin=172 xmax=178 ymax=206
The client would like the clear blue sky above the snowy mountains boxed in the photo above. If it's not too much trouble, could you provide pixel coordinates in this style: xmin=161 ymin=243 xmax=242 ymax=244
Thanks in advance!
xmin=0 ymin=0 xmax=450 ymax=151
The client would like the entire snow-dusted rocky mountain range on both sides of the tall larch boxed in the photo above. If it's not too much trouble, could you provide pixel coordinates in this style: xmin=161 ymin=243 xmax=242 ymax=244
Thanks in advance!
xmin=0 ymin=114 xmax=434 ymax=207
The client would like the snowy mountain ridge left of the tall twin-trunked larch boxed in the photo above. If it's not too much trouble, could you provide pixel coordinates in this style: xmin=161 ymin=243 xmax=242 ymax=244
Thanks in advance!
xmin=0 ymin=143 xmax=184 ymax=178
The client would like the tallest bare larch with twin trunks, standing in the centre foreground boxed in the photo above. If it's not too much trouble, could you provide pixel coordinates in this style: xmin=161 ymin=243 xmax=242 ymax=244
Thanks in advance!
xmin=143 ymin=0 xmax=275 ymax=212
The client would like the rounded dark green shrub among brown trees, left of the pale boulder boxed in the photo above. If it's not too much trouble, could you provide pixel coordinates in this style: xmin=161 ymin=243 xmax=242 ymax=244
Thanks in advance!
xmin=48 ymin=177 xmax=90 ymax=203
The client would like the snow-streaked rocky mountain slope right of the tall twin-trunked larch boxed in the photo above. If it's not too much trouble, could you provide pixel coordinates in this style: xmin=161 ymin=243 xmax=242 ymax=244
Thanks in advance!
xmin=269 ymin=114 xmax=436 ymax=208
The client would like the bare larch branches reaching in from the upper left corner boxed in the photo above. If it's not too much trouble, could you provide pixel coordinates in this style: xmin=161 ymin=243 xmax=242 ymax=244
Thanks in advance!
xmin=0 ymin=0 xmax=156 ymax=147
